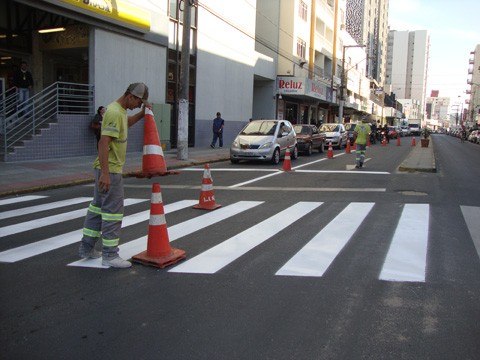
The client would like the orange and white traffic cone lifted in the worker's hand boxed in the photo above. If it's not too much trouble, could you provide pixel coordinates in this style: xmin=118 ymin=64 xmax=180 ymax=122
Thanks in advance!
xmin=137 ymin=107 xmax=178 ymax=179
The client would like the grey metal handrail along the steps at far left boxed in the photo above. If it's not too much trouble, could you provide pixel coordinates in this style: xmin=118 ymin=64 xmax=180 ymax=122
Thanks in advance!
xmin=0 ymin=82 xmax=94 ymax=153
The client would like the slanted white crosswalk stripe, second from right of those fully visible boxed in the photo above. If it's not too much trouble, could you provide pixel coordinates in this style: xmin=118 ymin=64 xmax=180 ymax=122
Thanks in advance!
xmin=276 ymin=203 xmax=374 ymax=276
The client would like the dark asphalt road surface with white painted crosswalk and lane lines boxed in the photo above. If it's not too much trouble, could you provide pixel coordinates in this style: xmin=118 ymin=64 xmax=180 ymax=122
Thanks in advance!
xmin=0 ymin=135 xmax=480 ymax=360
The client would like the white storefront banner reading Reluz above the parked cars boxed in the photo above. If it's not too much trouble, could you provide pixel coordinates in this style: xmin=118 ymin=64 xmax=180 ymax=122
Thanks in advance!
xmin=277 ymin=76 xmax=331 ymax=101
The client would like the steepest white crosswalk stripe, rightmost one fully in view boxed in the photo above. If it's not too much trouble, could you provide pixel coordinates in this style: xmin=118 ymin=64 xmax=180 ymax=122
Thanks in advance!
xmin=380 ymin=204 xmax=430 ymax=282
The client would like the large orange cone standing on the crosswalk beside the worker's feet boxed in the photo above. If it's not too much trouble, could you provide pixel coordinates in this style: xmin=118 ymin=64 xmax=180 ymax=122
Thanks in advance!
xmin=132 ymin=183 xmax=186 ymax=268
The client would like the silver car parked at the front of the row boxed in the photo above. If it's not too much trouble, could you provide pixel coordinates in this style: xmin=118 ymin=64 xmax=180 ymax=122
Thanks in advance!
xmin=230 ymin=120 xmax=298 ymax=164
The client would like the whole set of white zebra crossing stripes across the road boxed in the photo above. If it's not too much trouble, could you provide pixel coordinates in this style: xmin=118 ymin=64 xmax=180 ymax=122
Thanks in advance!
xmin=0 ymin=196 xmax=480 ymax=282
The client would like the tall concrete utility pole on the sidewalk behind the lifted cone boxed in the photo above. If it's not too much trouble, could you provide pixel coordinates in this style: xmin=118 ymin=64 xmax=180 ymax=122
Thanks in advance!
xmin=177 ymin=0 xmax=193 ymax=160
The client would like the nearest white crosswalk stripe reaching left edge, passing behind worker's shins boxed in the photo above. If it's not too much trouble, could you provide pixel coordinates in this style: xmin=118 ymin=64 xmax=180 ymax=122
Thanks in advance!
xmin=0 ymin=200 xmax=198 ymax=263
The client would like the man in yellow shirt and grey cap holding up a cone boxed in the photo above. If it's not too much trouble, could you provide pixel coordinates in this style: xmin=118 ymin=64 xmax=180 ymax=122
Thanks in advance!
xmin=79 ymin=83 xmax=148 ymax=268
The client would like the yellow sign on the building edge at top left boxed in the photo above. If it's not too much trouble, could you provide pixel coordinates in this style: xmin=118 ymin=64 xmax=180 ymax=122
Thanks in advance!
xmin=62 ymin=0 xmax=150 ymax=30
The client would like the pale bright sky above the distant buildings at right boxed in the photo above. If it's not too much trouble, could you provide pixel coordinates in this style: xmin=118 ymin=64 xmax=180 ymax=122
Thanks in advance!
xmin=388 ymin=0 xmax=480 ymax=101
